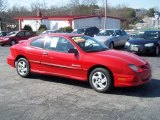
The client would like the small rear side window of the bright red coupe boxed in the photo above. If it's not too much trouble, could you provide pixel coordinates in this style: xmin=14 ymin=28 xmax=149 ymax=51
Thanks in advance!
xmin=30 ymin=38 xmax=44 ymax=48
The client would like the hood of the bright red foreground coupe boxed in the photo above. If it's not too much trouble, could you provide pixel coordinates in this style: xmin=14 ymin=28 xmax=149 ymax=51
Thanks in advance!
xmin=89 ymin=50 xmax=146 ymax=66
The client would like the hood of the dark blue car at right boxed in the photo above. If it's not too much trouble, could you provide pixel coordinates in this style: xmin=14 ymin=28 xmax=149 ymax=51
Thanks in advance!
xmin=128 ymin=38 xmax=157 ymax=45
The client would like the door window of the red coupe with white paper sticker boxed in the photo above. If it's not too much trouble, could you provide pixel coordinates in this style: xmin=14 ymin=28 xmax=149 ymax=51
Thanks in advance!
xmin=45 ymin=37 xmax=74 ymax=52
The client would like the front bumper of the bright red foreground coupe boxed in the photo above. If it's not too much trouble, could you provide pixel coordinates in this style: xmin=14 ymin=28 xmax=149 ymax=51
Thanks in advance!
xmin=114 ymin=69 xmax=152 ymax=87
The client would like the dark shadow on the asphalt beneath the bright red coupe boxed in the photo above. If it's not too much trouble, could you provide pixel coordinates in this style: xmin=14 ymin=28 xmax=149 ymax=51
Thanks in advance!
xmin=31 ymin=74 xmax=160 ymax=98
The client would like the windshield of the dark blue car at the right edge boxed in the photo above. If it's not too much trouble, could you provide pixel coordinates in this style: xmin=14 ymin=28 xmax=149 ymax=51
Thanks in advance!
xmin=132 ymin=31 xmax=159 ymax=40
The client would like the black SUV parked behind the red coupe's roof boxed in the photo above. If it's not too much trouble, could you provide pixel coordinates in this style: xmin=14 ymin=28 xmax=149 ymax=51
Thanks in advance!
xmin=72 ymin=27 xmax=99 ymax=37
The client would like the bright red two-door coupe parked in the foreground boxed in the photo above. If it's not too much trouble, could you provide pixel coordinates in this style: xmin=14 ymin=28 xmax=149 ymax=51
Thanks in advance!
xmin=7 ymin=33 xmax=151 ymax=92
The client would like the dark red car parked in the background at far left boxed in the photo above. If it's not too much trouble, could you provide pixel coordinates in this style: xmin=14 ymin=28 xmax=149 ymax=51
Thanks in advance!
xmin=0 ymin=30 xmax=35 ymax=46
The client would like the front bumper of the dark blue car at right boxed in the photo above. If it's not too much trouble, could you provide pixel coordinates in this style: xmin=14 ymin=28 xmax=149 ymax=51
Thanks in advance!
xmin=125 ymin=44 xmax=156 ymax=54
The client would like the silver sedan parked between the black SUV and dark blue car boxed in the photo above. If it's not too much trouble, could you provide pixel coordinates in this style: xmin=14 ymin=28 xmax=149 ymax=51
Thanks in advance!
xmin=94 ymin=29 xmax=130 ymax=48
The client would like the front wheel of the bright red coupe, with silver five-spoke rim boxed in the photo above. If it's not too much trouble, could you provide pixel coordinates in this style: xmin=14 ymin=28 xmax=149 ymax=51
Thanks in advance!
xmin=89 ymin=68 xmax=113 ymax=93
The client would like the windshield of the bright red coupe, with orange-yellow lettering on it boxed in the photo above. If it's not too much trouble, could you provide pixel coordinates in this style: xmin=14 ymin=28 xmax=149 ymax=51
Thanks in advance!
xmin=71 ymin=36 xmax=108 ymax=52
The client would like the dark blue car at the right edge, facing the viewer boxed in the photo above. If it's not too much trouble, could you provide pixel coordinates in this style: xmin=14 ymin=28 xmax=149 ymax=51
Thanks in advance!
xmin=125 ymin=30 xmax=160 ymax=56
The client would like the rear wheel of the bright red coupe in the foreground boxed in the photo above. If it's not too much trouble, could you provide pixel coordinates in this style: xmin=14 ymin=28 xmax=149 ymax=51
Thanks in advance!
xmin=16 ymin=58 xmax=30 ymax=78
